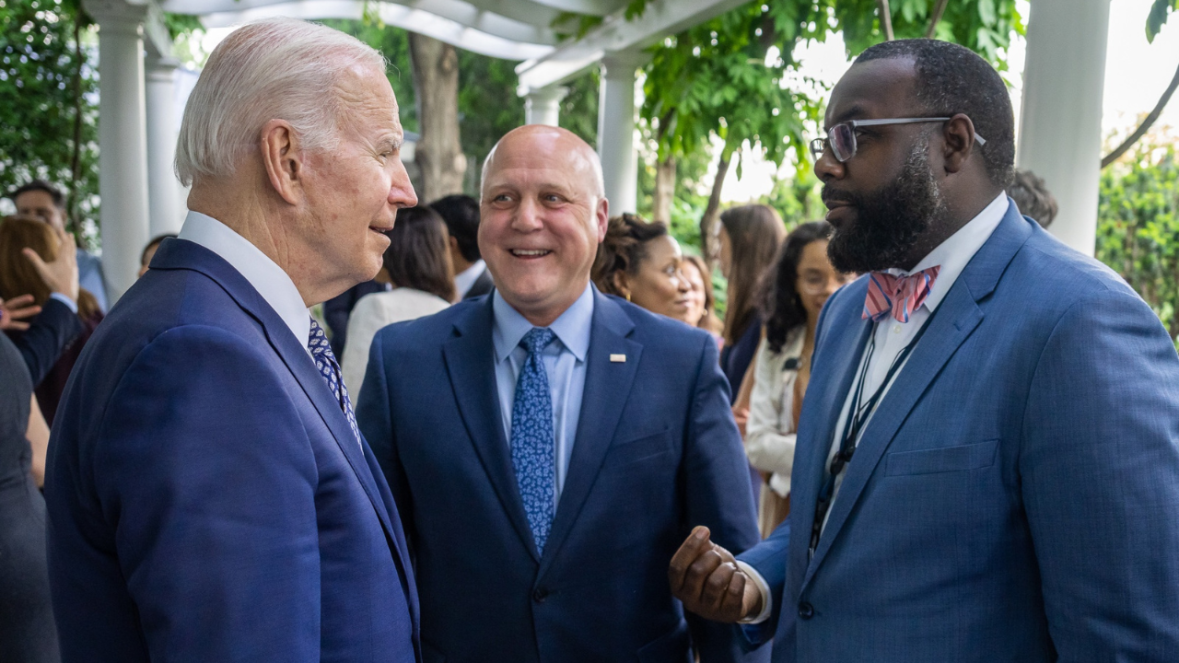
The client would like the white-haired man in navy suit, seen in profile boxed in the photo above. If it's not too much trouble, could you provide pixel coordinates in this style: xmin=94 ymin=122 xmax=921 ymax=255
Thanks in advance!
xmin=45 ymin=20 xmax=420 ymax=663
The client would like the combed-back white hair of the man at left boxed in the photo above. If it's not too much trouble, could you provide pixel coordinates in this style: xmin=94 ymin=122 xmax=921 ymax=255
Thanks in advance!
xmin=176 ymin=19 xmax=386 ymax=186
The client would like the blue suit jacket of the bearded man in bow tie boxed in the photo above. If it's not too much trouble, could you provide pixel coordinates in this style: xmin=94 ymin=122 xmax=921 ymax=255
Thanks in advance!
xmin=743 ymin=203 xmax=1179 ymax=663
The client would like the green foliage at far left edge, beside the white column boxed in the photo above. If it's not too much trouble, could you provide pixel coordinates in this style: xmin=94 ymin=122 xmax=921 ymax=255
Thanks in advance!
xmin=0 ymin=0 xmax=98 ymax=239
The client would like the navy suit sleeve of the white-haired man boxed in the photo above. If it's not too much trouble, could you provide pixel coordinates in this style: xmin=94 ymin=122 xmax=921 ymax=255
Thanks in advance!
xmin=91 ymin=327 xmax=321 ymax=663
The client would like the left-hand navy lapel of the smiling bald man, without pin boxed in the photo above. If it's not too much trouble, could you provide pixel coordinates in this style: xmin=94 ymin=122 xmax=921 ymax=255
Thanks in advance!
xmin=442 ymin=297 xmax=540 ymax=562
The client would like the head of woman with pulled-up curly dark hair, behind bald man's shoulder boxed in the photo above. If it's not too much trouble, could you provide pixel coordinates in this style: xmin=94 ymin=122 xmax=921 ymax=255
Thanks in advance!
xmin=592 ymin=214 xmax=699 ymax=327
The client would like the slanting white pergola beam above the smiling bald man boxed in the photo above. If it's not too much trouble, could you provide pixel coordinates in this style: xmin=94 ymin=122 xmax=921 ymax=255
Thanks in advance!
xmin=516 ymin=0 xmax=749 ymax=96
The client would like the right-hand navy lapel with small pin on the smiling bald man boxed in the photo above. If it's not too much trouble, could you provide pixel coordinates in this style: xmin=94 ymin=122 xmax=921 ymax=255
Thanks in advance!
xmin=538 ymin=289 xmax=643 ymax=577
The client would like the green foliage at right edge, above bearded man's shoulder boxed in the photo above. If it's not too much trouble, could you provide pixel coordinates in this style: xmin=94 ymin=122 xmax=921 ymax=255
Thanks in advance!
xmin=1096 ymin=144 xmax=1179 ymax=346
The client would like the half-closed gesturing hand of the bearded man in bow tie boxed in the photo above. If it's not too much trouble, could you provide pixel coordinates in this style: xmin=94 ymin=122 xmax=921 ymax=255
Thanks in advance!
xmin=667 ymin=527 xmax=762 ymax=624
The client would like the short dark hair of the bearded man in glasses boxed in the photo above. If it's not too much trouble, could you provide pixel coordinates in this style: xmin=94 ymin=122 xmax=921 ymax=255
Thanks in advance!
xmin=856 ymin=39 xmax=1015 ymax=189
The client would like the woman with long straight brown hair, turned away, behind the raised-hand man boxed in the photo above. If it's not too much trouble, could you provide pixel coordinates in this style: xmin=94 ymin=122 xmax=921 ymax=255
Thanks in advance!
xmin=713 ymin=205 xmax=786 ymax=394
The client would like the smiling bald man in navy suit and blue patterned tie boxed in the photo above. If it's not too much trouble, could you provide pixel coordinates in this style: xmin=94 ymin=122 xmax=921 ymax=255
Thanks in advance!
xmin=358 ymin=125 xmax=759 ymax=663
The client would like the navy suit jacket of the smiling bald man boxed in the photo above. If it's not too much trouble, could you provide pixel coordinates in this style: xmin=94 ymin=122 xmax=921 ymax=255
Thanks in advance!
xmin=358 ymin=291 xmax=764 ymax=663
